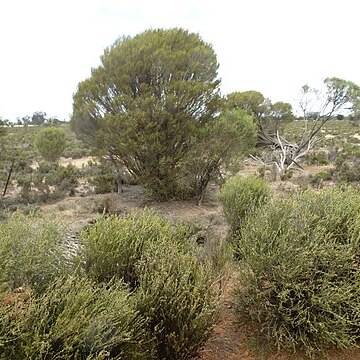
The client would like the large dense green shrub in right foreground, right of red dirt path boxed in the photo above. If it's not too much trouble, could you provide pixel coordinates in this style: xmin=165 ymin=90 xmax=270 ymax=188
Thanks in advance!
xmin=235 ymin=188 xmax=360 ymax=354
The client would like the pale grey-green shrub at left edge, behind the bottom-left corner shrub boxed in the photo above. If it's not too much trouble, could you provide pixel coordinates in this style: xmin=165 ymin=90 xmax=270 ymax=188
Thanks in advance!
xmin=0 ymin=212 xmax=67 ymax=292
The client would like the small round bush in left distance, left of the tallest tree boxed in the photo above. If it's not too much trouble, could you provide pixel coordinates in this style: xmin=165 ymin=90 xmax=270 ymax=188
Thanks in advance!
xmin=35 ymin=127 xmax=66 ymax=161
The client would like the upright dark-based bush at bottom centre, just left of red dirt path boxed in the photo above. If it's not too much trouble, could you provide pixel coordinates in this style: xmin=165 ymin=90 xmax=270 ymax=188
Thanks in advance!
xmin=136 ymin=248 xmax=218 ymax=360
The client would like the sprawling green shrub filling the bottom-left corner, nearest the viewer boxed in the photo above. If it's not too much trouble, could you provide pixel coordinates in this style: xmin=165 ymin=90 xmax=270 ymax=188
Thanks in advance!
xmin=0 ymin=278 xmax=154 ymax=360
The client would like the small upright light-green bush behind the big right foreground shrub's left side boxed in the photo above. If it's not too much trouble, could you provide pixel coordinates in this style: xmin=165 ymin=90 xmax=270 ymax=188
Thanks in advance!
xmin=220 ymin=176 xmax=270 ymax=232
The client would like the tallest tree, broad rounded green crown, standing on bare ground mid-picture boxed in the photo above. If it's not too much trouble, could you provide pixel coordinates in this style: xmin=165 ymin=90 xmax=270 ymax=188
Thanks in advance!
xmin=71 ymin=29 xmax=256 ymax=199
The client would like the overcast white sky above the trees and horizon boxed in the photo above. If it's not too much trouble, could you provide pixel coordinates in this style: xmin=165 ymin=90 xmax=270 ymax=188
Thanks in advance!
xmin=0 ymin=0 xmax=360 ymax=120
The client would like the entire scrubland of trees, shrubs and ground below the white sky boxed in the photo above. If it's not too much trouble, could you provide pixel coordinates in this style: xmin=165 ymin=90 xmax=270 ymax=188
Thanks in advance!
xmin=0 ymin=29 xmax=360 ymax=360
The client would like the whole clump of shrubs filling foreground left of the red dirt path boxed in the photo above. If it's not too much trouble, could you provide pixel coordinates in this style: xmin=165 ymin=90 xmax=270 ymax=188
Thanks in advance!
xmin=0 ymin=210 xmax=219 ymax=360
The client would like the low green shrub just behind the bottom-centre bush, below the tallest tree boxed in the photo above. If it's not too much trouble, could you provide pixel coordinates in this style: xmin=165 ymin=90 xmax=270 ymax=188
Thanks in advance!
xmin=78 ymin=210 xmax=190 ymax=289
